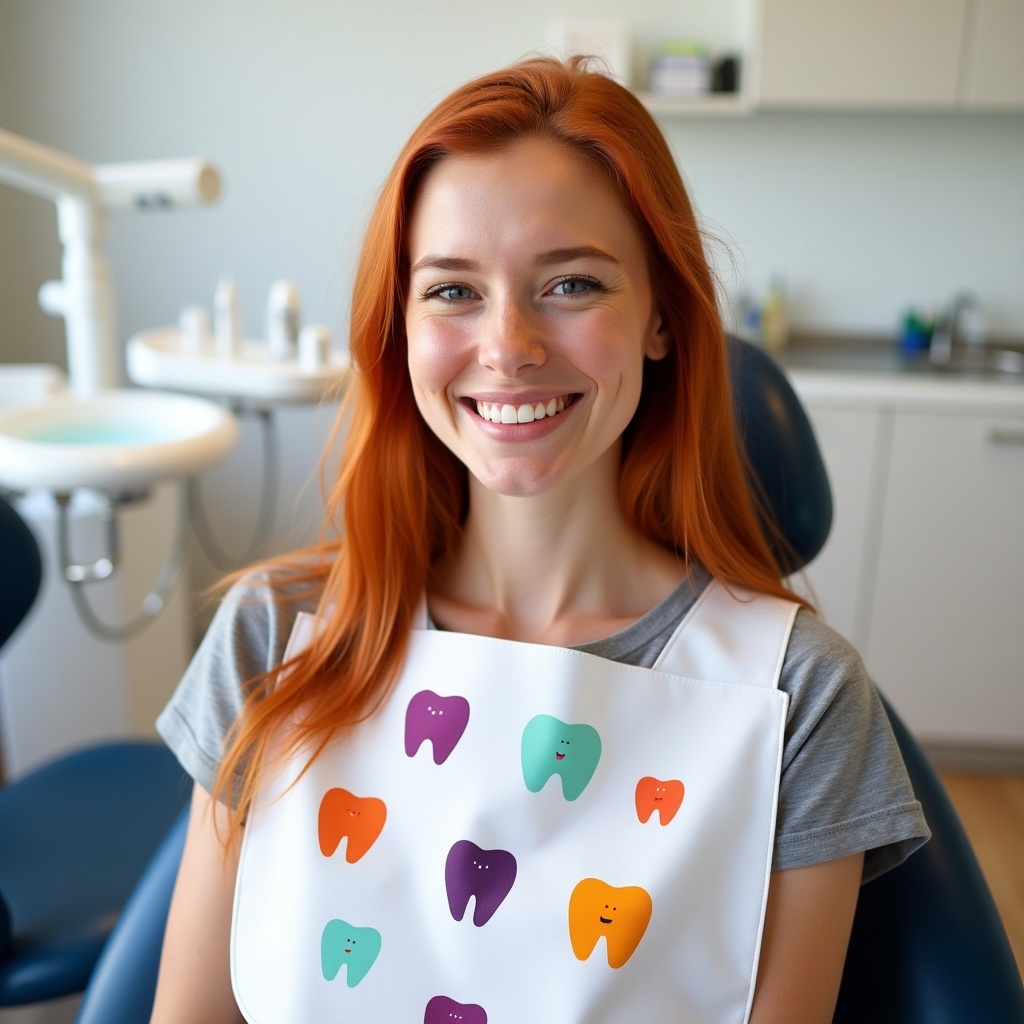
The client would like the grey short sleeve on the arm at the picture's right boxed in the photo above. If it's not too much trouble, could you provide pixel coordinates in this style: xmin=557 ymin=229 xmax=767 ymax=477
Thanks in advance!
xmin=773 ymin=610 xmax=930 ymax=882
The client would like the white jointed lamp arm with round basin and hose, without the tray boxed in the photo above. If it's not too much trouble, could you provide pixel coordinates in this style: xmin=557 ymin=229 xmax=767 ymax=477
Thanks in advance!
xmin=0 ymin=130 xmax=238 ymax=640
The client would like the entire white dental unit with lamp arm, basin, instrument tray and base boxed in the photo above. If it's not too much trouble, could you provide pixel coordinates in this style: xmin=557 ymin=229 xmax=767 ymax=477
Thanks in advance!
xmin=0 ymin=130 xmax=347 ymax=778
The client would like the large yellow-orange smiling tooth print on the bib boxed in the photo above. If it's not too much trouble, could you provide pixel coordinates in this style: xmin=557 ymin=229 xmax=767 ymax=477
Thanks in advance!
xmin=569 ymin=879 xmax=654 ymax=968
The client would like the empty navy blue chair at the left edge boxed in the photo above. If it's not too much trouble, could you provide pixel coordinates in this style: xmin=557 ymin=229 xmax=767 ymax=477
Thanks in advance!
xmin=0 ymin=497 xmax=191 ymax=1008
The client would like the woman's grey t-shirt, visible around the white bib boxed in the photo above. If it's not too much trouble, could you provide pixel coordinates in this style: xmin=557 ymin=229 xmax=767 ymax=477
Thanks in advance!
xmin=157 ymin=571 xmax=929 ymax=882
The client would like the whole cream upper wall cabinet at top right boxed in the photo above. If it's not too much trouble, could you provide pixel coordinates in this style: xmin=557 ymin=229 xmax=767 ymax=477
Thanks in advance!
xmin=753 ymin=0 xmax=1024 ymax=111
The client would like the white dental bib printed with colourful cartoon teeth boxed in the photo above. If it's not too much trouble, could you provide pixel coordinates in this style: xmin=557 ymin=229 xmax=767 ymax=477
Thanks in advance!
xmin=231 ymin=583 xmax=797 ymax=1024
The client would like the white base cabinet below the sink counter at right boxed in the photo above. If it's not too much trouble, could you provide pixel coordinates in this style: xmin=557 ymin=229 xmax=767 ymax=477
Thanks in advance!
xmin=793 ymin=382 xmax=1024 ymax=751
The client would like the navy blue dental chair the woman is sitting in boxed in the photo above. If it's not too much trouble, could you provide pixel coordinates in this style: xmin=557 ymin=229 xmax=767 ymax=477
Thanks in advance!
xmin=77 ymin=339 xmax=1024 ymax=1024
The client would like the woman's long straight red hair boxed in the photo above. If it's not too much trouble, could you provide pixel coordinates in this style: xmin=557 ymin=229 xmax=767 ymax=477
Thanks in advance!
xmin=215 ymin=58 xmax=793 ymax=836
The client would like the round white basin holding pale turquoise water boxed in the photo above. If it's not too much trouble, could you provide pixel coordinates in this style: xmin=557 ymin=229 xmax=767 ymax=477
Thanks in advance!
xmin=0 ymin=389 xmax=239 ymax=495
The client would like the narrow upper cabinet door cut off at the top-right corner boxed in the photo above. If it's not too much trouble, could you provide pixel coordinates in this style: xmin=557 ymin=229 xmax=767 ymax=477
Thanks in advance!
xmin=963 ymin=0 xmax=1024 ymax=110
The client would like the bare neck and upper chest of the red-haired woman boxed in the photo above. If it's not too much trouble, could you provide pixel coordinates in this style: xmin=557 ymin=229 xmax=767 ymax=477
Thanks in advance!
xmin=429 ymin=468 xmax=686 ymax=646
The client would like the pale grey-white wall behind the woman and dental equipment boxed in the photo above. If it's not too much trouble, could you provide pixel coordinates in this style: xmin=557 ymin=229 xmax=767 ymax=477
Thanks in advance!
xmin=0 ymin=0 xmax=1024 ymax=614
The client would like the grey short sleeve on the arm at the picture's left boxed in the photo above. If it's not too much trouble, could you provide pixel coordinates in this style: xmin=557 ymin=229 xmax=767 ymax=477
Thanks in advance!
xmin=157 ymin=575 xmax=315 ymax=792
